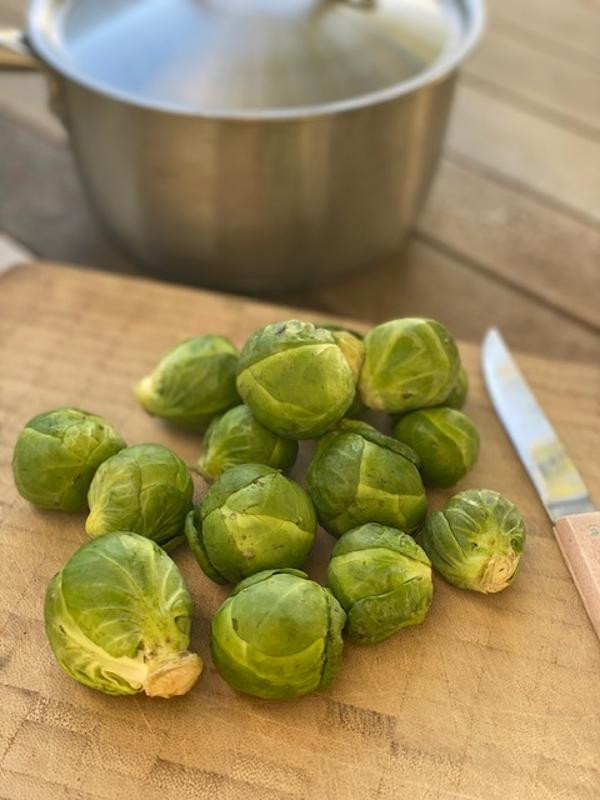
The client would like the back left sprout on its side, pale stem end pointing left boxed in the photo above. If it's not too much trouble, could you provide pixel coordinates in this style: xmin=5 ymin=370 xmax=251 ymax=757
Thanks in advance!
xmin=135 ymin=334 xmax=240 ymax=431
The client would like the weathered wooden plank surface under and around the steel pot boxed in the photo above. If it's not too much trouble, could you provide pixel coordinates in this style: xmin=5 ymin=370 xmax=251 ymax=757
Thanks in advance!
xmin=0 ymin=0 xmax=600 ymax=360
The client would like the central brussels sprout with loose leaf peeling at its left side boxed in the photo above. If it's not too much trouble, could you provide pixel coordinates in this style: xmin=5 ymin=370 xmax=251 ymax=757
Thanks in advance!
xmin=185 ymin=464 xmax=317 ymax=583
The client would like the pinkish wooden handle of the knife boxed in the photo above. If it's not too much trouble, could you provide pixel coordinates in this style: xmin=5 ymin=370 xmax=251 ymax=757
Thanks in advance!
xmin=554 ymin=511 xmax=600 ymax=638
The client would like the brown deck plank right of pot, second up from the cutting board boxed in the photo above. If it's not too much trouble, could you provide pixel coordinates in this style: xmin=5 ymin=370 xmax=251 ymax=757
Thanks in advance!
xmin=417 ymin=159 xmax=600 ymax=330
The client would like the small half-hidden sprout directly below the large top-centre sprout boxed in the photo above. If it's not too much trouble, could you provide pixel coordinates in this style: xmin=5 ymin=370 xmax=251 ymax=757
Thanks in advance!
xmin=198 ymin=405 xmax=298 ymax=480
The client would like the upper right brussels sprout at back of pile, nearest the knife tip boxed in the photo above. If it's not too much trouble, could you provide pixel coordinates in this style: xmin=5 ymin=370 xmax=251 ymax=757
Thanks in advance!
xmin=359 ymin=318 xmax=460 ymax=413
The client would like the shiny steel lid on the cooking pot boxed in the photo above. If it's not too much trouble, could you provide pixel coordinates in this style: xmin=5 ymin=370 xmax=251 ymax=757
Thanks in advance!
xmin=29 ymin=0 xmax=481 ymax=116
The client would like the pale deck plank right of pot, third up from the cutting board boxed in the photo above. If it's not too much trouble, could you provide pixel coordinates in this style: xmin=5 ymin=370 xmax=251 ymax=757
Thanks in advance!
xmin=447 ymin=85 xmax=600 ymax=223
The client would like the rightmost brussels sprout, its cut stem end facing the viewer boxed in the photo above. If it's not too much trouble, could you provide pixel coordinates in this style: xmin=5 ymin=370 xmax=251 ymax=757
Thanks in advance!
xmin=422 ymin=489 xmax=525 ymax=594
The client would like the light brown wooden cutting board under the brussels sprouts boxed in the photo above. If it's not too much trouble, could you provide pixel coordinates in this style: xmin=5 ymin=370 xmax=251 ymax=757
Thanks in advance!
xmin=0 ymin=265 xmax=600 ymax=800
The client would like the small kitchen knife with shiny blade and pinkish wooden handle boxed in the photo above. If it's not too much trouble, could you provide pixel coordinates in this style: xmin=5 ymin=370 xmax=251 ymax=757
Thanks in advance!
xmin=481 ymin=328 xmax=600 ymax=637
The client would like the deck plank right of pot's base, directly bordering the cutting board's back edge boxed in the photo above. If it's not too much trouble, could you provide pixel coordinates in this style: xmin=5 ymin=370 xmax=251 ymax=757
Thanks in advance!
xmin=304 ymin=239 xmax=600 ymax=363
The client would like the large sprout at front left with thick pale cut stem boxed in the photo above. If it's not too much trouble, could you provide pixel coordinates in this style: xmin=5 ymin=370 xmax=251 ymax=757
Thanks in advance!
xmin=45 ymin=532 xmax=202 ymax=697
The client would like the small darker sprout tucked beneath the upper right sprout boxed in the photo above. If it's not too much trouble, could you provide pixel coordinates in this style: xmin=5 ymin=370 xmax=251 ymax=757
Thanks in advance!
xmin=394 ymin=406 xmax=479 ymax=486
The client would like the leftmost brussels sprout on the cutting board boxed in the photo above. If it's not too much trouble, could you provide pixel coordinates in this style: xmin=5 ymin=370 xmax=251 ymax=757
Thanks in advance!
xmin=12 ymin=408 xmax=127 ymax=511
